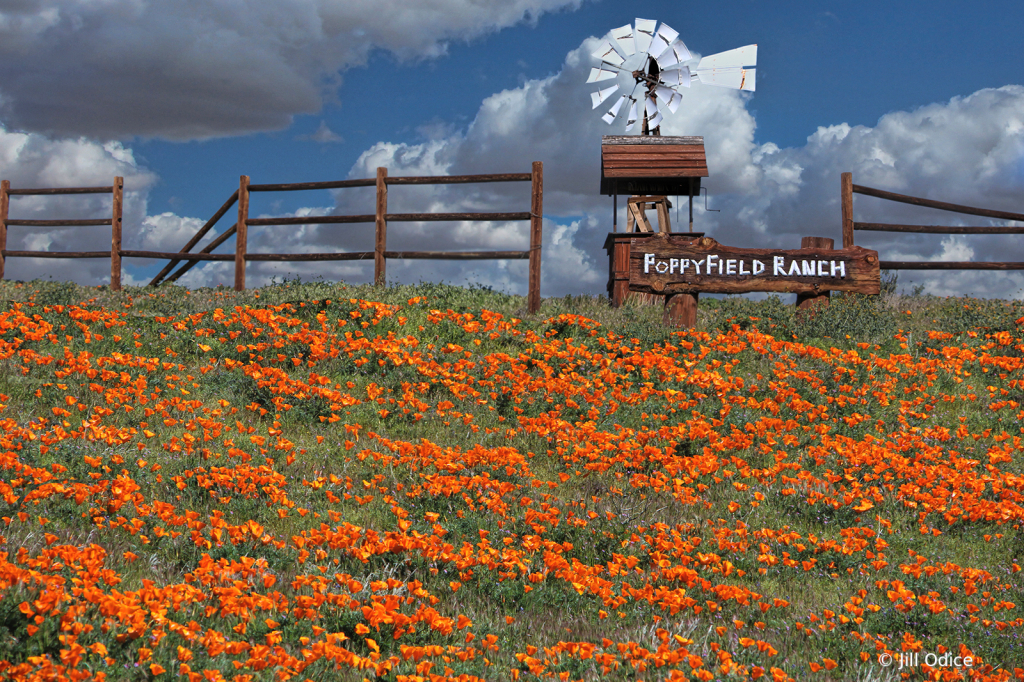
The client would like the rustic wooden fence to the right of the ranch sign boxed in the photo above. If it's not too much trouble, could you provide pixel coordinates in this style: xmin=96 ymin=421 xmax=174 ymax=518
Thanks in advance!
xmin=840 ymin=173 xmax=1024 ymax=270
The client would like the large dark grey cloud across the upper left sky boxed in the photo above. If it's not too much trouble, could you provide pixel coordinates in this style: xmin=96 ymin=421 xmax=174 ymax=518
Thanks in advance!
xmin=0 ymin=0 xmax=580 ymax=139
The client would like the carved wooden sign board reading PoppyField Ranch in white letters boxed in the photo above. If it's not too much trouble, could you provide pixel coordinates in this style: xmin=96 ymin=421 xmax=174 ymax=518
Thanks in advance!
xmin=629 ymin=235 xmax=882 ymax=295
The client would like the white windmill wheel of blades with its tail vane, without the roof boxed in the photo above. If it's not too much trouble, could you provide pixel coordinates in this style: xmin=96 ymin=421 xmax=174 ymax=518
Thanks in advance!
xmin=587 ymin=18 xmax=758 ymax=135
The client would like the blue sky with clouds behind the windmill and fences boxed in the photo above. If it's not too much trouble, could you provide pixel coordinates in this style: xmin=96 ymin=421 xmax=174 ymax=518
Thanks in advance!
xmin=0 ymin=0 xmax=1024 ymax=297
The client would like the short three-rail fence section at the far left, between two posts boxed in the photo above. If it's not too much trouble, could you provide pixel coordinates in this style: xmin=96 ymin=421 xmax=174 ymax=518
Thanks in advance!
xmin=0 ymin=176 xmax=125 ymax=290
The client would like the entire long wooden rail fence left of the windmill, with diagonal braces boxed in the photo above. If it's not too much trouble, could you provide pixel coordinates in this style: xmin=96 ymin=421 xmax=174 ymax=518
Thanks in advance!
xmin=0 ymin=161 xmax=544 ymax=312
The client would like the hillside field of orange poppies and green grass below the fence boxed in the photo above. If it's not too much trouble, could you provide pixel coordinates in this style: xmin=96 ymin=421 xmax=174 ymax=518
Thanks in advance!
xmin=0 ymin=283 xmax=1024 ymax=682
